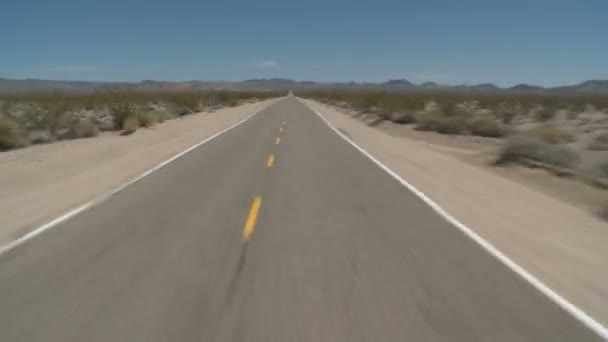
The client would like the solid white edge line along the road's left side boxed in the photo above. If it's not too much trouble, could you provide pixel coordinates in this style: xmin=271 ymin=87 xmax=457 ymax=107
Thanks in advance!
xmin=0 ymin=106 xmax=267 ymax=255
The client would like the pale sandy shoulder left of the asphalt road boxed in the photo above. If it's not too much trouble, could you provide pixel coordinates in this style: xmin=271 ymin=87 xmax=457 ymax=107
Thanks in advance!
xmin=0 ymin=100 xmax=275 ymax=244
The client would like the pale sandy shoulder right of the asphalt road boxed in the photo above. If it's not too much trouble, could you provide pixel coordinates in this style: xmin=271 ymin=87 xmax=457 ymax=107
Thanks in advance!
xmin=304 ymin=100 xmax=608 ymax=324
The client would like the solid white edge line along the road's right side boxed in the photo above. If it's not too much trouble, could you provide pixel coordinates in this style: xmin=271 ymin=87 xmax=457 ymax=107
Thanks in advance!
xmin=300 ymin=100 xmax=608 ymax=340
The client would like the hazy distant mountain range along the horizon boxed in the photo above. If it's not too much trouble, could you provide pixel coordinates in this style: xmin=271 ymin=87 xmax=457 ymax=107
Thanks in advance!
xmin=0 ymin=78 xmax=608 ymax=95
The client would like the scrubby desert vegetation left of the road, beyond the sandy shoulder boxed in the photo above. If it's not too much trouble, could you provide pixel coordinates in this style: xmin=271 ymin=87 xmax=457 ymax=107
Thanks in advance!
xmin=0 ymin=90 xmax=279 ymax=150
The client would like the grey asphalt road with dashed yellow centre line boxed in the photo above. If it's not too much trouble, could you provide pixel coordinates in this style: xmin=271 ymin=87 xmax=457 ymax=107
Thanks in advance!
xmin=0 ymin=98 xmax=599 ymax=342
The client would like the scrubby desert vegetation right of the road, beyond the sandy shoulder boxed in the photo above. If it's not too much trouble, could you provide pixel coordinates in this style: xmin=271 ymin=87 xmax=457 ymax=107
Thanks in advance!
xmin=298 ymin=89 xmax=608 ymax=186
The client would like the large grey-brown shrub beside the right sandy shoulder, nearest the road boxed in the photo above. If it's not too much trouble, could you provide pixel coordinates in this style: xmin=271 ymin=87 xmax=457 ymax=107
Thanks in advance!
xmin=496 ymin=135 xmax=580 ymax=168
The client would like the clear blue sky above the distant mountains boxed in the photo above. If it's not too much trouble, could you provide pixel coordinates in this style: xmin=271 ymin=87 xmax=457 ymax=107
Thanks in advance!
xmin=0 ymin=0 xmax=608 ymax=86
